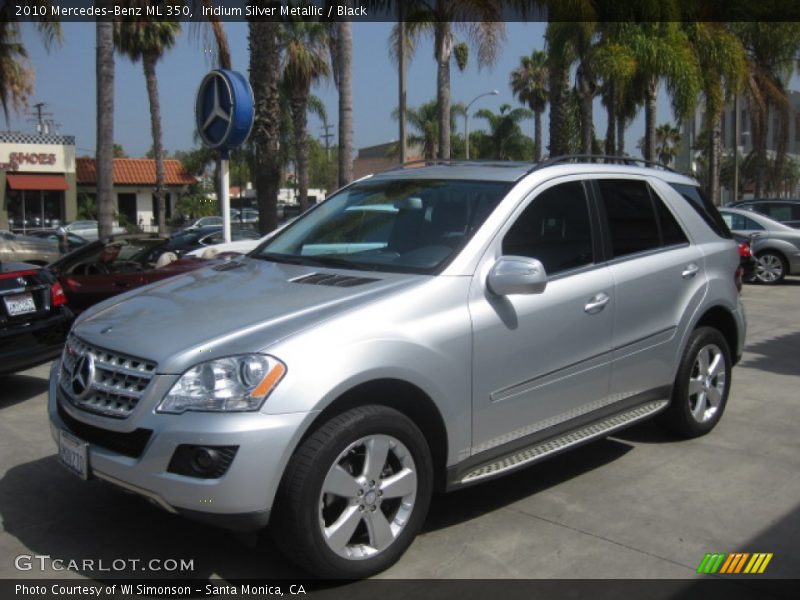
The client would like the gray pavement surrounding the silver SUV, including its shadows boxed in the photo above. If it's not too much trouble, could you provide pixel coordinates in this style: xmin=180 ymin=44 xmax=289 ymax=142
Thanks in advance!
xmin=0 ymin=277 xmax=800 ymax=581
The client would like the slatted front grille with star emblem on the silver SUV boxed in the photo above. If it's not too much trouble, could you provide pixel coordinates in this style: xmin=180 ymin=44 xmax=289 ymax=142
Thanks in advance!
xmin=59 ymin=335 xmax=156 ymax=419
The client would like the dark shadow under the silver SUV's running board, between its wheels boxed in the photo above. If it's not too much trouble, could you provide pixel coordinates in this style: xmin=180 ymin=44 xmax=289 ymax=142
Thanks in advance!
xmin=422 ymin=439 xmax=633 ymax=532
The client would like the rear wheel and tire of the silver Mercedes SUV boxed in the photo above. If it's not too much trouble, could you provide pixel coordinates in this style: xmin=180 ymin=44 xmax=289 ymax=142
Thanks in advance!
xmin=662 ymin=327 xmax=732 ymax=438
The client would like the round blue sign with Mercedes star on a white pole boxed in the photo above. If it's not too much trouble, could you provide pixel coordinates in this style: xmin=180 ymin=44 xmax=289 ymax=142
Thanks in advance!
xmin=195 ymin=69 xmax=254 ymax=153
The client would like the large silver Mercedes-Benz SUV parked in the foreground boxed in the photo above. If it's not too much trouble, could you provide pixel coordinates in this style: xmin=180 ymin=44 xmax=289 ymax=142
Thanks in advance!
xmin=49 ymin=159 xmax=745 ymax=577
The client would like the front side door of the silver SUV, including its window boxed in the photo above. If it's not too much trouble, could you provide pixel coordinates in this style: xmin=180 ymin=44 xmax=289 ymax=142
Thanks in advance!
xmin=470 ymin=180 xmax=614 ymax=453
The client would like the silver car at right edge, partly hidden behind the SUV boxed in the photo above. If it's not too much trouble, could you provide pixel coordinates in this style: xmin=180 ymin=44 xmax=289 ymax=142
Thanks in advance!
xmin=720 ymin=208 xmax=800 ymax=284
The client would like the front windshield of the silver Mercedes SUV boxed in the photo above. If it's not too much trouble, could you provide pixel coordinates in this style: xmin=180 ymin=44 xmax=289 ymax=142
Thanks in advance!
xmin=251 ymin=179 xmax=511 ymax=273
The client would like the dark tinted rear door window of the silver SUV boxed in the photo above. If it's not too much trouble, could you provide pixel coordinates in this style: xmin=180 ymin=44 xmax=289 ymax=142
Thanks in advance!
xmin=597 ymin=179 xmax=661 ymax=258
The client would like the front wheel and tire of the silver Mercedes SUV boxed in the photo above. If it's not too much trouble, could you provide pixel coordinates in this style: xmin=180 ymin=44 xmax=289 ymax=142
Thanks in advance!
xmin=271 ymin=405 xmax=433 ymax=578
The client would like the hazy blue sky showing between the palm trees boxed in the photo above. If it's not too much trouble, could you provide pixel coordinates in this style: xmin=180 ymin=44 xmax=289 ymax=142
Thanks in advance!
xmin=10 ymin=22 xmax=674 ymax=157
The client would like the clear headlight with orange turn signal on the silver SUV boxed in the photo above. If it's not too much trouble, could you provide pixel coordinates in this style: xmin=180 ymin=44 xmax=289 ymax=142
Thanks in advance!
xmin=157 ymin=354 xmax=286 ymax=413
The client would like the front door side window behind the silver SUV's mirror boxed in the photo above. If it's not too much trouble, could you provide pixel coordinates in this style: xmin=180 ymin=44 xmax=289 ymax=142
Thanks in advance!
xmin=503 ymin=181 xmax=594 ymax=274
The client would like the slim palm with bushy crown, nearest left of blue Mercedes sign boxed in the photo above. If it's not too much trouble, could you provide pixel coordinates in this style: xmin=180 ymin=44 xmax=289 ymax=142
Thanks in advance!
xmin=114 ymin=20 xmax=181 ymax=233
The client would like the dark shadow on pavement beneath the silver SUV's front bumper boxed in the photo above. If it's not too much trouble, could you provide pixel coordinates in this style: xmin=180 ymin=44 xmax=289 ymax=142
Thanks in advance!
xmin=0 ymin=456 xmax=305 ymax=581
